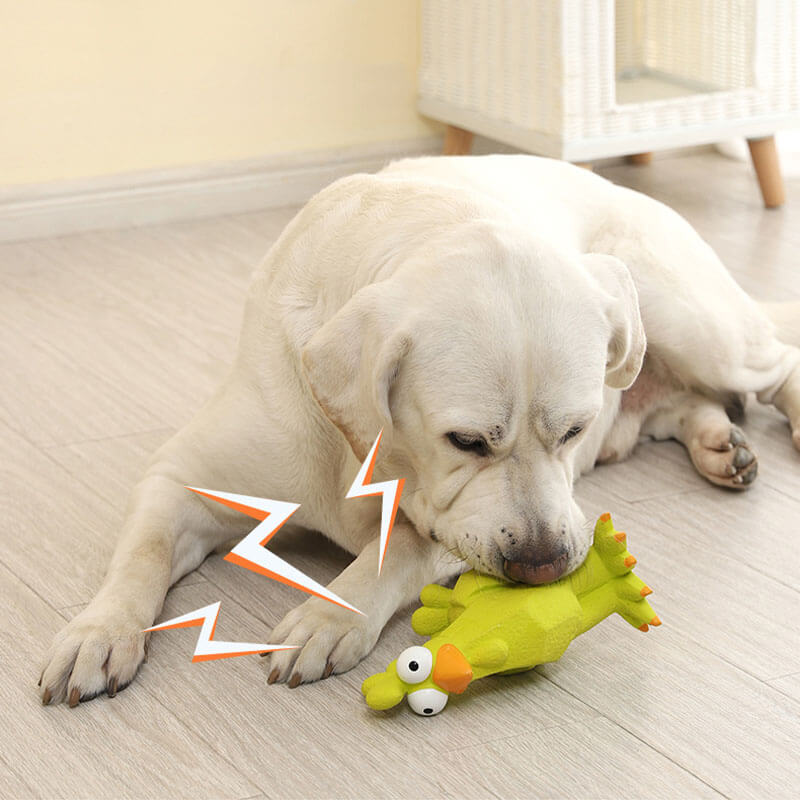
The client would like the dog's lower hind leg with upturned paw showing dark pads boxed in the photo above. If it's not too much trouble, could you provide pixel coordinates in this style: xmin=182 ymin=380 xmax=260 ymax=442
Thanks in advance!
xmin=642 ymin=392 xmax=758 ymax=489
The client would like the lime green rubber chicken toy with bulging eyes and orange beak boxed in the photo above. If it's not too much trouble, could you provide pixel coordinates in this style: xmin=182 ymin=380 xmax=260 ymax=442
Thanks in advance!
xmin=361 ymin=514 xmax=661 ymax=716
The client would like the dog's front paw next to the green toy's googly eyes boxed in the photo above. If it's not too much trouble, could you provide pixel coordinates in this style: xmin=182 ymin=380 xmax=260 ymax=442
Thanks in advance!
xmin=265 ymin=597 xmax=380 ymax=689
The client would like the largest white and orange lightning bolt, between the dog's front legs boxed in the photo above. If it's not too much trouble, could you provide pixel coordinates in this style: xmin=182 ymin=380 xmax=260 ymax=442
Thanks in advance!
xmin=186 ymin=484 xmax=362 ymax=616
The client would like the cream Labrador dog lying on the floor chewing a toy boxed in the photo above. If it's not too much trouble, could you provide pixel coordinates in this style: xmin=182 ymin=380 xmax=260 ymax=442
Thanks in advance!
xmin=40 ymin=155 xmax=800 ymax=706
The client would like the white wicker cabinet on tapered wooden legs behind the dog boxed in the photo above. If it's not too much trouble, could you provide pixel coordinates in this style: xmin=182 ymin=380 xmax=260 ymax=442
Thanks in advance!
xmin=418 ymin=0 xmax=800 ymax=205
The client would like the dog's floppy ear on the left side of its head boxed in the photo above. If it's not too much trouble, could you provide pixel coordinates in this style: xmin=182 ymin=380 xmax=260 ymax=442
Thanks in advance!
xmin=302 ymin=281 xmax=411 ymax=461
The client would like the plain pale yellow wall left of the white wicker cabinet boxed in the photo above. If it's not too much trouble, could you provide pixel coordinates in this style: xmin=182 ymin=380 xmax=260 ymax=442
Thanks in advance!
xmin=0 ymin=0 xmax=433 ymax=185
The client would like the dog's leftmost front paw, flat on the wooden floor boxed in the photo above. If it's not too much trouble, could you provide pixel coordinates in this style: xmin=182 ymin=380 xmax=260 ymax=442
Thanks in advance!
xmin=39 ymin=605 xmax=149 ymax=707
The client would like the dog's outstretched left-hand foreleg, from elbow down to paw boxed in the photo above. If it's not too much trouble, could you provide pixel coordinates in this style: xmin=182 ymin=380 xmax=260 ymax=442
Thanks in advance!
xmin=39 ymin=463 xmax=236 ymax=706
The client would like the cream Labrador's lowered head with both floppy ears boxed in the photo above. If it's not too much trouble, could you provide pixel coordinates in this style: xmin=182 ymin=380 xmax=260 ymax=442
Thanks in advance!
xmin=303 ymin=222 xmax=645 ymax=584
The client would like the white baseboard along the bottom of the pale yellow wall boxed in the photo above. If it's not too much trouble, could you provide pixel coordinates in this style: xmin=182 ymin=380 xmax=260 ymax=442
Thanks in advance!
xmin=0 ymin=137 xmax=441 ymax=242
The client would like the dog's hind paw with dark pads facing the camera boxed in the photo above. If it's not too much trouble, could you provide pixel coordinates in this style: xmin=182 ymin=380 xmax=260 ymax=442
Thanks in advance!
xmin=689 ymin=425 xmax=758 ymax=489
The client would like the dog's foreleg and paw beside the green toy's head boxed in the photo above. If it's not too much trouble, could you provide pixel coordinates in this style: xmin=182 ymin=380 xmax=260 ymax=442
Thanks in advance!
xmin=267 ymin=515 xmax=464 ymax=688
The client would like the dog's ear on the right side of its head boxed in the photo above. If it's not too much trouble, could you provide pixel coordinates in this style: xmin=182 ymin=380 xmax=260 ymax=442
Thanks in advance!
xmin=583 ymin=253 xmax=647 ymax=389
